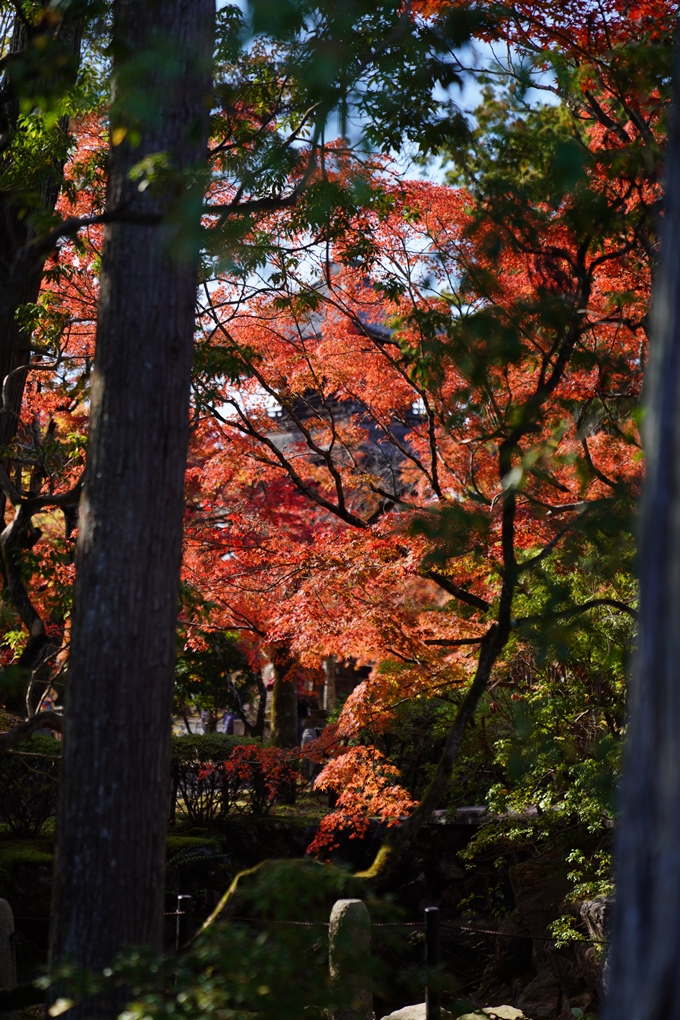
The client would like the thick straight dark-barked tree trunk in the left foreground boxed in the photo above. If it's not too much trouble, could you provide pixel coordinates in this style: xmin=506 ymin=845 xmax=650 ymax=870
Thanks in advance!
xmin=51 ymin=0 xmax=215 ymax=987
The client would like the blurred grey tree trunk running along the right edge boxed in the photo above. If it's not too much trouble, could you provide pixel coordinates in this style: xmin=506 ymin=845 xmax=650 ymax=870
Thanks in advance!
xmin=606 ymin=53 xmax=680 ymax=1020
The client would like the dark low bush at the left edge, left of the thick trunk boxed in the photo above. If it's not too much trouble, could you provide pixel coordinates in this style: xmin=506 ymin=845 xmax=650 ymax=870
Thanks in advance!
xmin=0 ymin=734 xmax=61 ymax=838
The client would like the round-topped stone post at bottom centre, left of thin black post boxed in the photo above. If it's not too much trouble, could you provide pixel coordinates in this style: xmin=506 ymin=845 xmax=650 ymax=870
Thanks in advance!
xmin=328 ymin=900 xmax=373 ymax=1020
